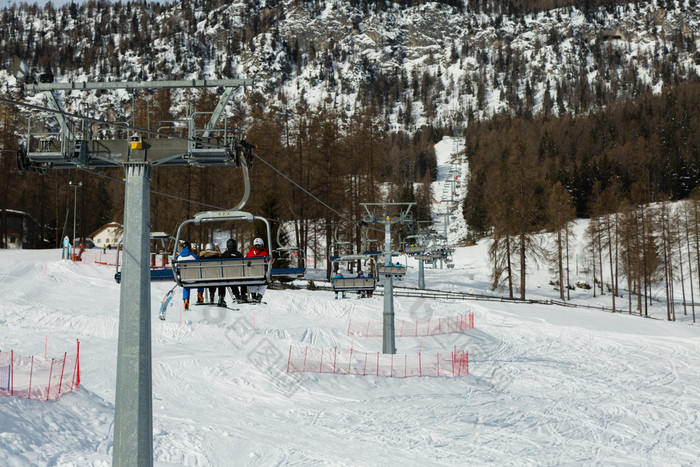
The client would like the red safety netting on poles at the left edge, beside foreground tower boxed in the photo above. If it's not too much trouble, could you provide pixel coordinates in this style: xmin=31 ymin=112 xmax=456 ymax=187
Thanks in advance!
xmin=0 ymin=342 xmax=80 ymax=401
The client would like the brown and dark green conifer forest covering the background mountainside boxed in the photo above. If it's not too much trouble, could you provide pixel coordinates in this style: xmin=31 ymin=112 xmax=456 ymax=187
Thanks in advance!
xmin=0 ymin=0 xmax=700 ymax=310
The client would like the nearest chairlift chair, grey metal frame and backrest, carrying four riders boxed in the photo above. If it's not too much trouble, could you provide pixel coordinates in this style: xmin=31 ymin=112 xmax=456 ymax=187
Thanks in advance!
xmin=173 ymin=210 xmax=272 ymax=288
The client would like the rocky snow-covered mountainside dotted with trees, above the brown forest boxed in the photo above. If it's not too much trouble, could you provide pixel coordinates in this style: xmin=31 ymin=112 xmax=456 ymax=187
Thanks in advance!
xmin=0 ymin=0 xmax=700 ymax=130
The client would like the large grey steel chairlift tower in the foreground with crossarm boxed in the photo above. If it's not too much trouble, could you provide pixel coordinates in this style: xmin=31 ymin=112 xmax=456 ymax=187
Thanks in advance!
xmin=18 ymin=79 xmax=254 ymax=467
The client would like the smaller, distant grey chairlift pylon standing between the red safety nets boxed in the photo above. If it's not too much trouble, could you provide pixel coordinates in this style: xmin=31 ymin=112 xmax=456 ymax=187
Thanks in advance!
xmin=360 ymin=203 xmax=416 ymax=354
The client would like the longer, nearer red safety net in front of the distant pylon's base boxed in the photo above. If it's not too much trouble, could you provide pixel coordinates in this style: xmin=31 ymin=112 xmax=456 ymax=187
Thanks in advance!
xmin=287 ymin=345 xmax=469 ymax=378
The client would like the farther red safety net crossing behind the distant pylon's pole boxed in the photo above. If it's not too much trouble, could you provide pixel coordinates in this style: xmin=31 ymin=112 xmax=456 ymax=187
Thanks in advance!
xmin=348 ymin=313 xmax=474 ymax=337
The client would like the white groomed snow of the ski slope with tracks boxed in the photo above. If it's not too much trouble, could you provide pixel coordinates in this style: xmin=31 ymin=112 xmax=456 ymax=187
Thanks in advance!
xmin=0 ymin=138 xmax=700 ymax=466
